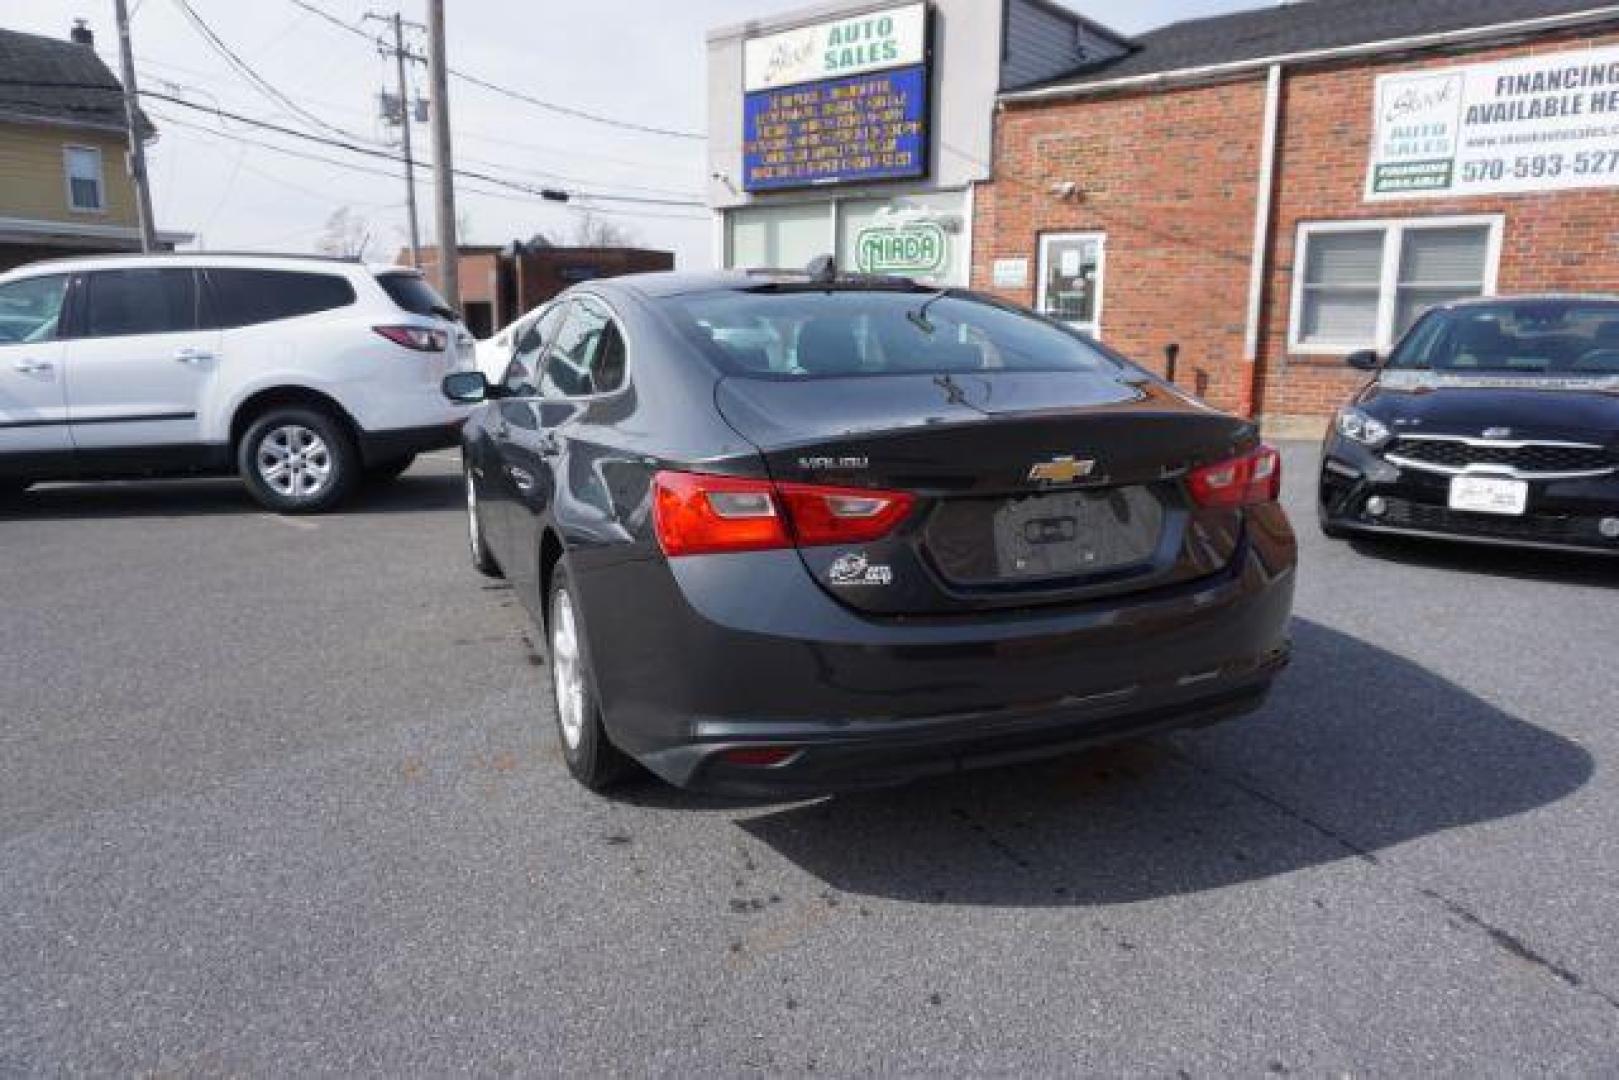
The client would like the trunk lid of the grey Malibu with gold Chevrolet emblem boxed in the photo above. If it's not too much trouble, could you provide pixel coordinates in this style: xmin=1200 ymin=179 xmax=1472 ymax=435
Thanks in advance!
xmin=716 ymin=369 xmax=1253 ymax=615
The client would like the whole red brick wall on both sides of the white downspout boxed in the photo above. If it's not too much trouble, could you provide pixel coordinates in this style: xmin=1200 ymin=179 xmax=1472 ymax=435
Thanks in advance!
xmin=973 ymin=25 xmax=1619 ymax=418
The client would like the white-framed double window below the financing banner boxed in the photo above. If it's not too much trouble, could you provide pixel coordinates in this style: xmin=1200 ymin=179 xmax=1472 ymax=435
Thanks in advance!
xmin=1289 ymin=217 xmax=1501 ymax=355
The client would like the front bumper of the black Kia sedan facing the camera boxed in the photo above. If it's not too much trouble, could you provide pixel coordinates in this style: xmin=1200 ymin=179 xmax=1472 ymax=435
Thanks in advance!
xmin=1318 ymin=434 xmax=1619 ymax=555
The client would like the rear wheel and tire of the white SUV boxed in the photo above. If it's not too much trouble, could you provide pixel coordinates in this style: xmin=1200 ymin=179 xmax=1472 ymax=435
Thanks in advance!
xmin=236 ymin=405 xmax=361 ymax=513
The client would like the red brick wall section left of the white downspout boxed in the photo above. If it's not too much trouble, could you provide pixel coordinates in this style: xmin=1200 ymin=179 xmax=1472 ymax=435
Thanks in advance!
xmin=973 ymin=81 xmax=1264 ymax=408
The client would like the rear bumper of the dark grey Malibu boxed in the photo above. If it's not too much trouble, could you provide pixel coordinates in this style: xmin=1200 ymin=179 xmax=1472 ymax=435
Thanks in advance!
xmin=570 ymin=512 xmax=1295 ymax=795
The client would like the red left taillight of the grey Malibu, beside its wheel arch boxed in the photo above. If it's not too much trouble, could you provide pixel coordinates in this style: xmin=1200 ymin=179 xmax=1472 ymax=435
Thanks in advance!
xmin=652 ymin=473 xmax=915 ymax=557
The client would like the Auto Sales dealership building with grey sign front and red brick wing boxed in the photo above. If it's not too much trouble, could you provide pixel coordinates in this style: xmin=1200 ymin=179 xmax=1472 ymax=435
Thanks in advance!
xmin=709 ymin=0 xmax=1619 ymax=431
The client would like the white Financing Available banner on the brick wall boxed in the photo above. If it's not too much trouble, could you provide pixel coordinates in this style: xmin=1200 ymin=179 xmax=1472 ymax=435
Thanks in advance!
xmin=1366 ymin=47 xmax=1619 ymax=201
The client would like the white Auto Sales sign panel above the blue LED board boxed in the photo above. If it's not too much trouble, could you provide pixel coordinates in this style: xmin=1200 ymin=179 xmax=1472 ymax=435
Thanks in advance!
xmin=743 ymin=3 xmax=928 ymax=94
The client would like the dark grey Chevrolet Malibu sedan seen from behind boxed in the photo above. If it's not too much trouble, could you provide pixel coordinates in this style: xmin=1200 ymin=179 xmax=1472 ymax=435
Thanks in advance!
xmin=445 ymin=274 xmax=1297 ymax=795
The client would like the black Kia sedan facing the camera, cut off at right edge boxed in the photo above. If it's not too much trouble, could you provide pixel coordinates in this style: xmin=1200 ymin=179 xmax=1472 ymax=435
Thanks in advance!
xmin=1319 ymin=296 xmax=1619 ymax=554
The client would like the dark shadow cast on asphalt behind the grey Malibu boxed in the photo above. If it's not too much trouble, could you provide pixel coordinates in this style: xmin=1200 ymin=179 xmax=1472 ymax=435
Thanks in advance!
xmin=738 ymin=620 xmax=1593 ymax=907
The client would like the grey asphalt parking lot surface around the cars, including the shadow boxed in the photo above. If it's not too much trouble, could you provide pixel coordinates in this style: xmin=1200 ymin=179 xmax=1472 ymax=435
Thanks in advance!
xmin=0 ymin=447 xmax=1619 ymax=1077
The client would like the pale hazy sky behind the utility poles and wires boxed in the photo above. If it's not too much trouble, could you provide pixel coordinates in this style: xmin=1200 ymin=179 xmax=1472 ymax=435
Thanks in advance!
xmin=0 ymin=0 xmax=1258 ymax=267
